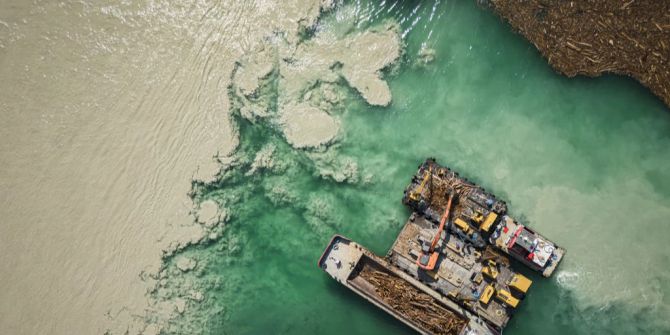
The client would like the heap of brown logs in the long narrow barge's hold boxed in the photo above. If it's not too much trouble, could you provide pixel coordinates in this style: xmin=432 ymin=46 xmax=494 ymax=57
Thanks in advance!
xmin=360 ymin=267 xmax=465 ymax=334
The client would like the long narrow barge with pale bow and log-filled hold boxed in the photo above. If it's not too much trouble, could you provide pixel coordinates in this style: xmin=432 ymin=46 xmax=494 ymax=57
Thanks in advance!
xmin=318 ymin=235 xmax=499 ymax=335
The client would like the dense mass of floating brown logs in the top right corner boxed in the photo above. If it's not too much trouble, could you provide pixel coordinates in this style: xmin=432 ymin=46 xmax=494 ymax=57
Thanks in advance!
xmin=489 ymin=0 xmax=670 ymax=106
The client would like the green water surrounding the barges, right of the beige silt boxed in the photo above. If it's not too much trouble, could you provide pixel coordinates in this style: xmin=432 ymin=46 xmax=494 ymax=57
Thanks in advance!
xmin=165 ymin=1 xmax=670 ymax=334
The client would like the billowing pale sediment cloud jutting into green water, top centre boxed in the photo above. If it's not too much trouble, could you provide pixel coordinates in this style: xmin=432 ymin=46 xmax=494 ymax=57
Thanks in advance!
xmin=232 ymin=22 xmax=402 ymax=149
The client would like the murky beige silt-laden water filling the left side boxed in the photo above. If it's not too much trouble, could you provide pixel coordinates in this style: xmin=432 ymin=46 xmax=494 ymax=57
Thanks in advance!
xmin=0 ymin=0 xmax=402 ymax=334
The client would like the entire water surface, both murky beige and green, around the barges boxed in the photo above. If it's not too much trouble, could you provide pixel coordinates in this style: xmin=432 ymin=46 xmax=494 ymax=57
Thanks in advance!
xmin=0 ymin=0 xmax=670 ymax=334
